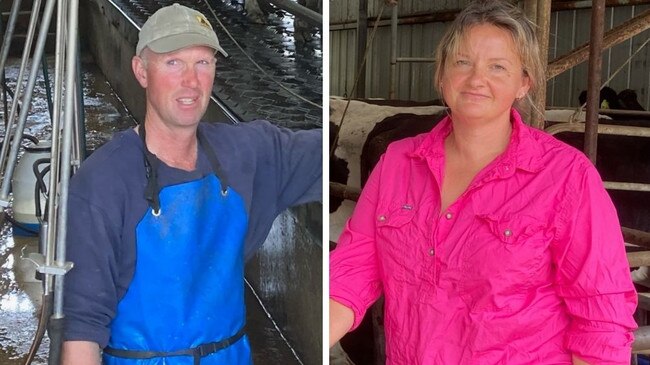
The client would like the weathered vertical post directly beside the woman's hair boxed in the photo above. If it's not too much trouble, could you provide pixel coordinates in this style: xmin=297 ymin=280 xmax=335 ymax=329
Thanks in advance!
xmin=530 ymin=0 xmax=551 ymax=129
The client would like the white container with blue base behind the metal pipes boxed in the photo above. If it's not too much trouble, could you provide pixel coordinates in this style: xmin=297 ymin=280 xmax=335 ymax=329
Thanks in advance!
xmin=11 ymin=141 xmax=52 ymax=235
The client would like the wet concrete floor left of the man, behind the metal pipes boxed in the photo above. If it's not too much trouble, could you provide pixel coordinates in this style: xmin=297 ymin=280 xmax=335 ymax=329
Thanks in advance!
xmin=0 ymin=57 xmax=135 ymax=365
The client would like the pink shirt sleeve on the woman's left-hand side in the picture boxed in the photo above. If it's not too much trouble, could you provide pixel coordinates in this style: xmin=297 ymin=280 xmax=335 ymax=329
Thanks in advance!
xmin=330 ymin=158 xmax=383 ymax=329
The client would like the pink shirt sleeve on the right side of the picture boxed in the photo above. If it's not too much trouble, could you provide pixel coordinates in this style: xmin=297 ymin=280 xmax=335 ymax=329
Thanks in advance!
xmin=554 ymin=161 xmax=637 ymax=364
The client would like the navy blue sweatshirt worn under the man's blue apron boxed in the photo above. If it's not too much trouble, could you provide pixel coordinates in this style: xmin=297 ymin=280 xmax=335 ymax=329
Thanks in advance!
xmin=64 ymin=121 xmax=322 ymax=348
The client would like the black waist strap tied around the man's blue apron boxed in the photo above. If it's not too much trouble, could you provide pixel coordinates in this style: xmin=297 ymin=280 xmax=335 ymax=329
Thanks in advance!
xmin=104 ymin=327 xmax=245 ymax=365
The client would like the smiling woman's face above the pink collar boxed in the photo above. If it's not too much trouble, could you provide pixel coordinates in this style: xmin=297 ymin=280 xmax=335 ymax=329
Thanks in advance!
xmin=441 ymin=24 xmax=530 ymax=122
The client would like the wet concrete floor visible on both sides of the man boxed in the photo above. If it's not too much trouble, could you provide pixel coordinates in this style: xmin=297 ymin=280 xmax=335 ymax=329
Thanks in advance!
xmin=0 ymin=52 xmax=314 ymax=365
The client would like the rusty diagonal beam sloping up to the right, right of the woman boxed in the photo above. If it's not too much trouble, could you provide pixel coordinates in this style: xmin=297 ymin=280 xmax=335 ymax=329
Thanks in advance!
xmin=546 ymin=9 xmax=650 ymax=79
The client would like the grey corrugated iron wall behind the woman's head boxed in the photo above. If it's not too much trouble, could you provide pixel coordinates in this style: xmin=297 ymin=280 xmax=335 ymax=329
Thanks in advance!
xmin=330 ymin=0 xmax=650 ymax=110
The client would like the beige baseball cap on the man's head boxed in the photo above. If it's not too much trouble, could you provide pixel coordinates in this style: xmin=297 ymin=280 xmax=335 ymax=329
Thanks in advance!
xmin=135 ymin=4 xmax=228 ymax=56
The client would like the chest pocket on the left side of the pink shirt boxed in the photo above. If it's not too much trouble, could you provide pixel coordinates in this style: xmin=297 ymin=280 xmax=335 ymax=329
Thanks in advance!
xmin=376 ymin=204 xmax=426 ymax=284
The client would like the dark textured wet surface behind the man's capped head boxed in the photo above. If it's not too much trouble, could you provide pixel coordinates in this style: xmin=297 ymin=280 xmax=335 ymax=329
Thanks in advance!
xmin=107 ymin=0 xmax=323 ymax=129
